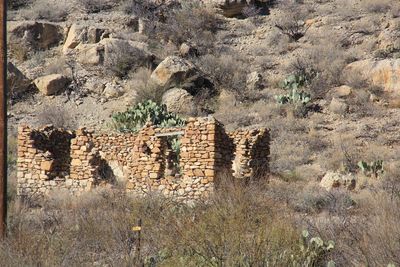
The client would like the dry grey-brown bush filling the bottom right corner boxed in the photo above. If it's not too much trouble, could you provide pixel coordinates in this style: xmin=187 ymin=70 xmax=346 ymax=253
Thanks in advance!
xmin=337 ymin=193 xmax=400 ymax=266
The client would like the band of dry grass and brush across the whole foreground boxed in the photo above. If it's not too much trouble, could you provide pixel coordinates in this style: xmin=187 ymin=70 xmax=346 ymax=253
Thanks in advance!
xmin=0 ymin=172 xmax=400 ymax=266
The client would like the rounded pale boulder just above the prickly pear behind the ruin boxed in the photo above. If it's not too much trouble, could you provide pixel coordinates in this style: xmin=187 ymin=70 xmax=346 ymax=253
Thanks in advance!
xmin=162 ymin=88 xmax=195 ymax=115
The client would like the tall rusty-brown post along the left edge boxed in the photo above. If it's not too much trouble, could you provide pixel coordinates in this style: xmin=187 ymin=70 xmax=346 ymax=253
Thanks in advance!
xmin=0 ymin=0 xmax=7 ymax=239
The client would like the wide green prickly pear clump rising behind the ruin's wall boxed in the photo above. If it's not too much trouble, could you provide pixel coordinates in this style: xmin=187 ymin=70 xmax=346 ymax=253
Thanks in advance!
xmin=112 ymin=100 xmax=185 ymax=132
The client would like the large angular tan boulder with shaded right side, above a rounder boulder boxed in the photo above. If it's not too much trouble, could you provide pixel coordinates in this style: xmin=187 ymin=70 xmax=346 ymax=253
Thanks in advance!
xmin=150 ymin=56 xmax=201 ymax=87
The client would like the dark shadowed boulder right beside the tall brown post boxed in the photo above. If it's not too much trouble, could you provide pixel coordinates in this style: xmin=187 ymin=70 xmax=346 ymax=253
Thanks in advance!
xmin=7 ymin=62 xmax=31 ymax=96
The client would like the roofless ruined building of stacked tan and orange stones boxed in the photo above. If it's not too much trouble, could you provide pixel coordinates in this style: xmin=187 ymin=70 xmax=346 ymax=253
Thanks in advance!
xmin=17 ymin=117 xmax=269 ymax=199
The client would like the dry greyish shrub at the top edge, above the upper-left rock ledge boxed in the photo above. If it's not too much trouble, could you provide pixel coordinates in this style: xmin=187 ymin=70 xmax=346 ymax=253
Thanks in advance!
xmin=21 ymin=0 xmax=73 ymax=22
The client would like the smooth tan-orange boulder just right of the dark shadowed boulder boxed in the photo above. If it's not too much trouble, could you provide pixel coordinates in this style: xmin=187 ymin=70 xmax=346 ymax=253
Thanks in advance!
xmin=34 ymin=74 xmax=70 ymax=96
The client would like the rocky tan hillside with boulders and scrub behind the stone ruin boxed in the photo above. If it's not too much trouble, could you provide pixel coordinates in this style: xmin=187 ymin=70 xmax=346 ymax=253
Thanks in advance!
xmin=7 ymin=0 xmax=400 ymax=182
